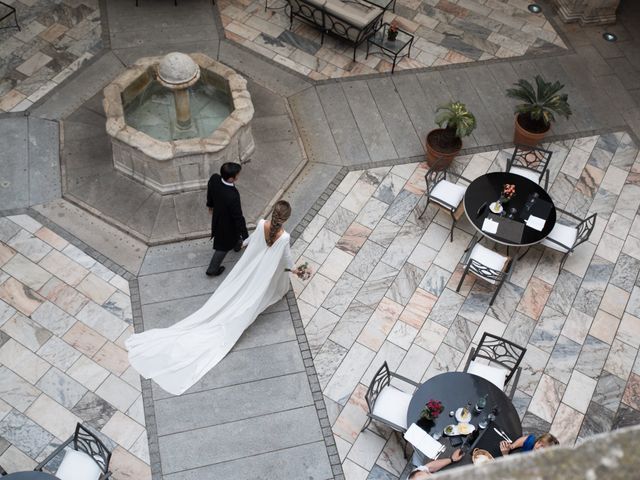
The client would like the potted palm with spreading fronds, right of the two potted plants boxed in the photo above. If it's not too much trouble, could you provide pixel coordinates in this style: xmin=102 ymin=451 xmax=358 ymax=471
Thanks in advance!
xmin=507 ymin=75 xmax=571 ymax=146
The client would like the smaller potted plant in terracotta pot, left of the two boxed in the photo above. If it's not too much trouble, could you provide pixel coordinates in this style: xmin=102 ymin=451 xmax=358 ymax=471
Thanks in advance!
xmin=427 ymin=102 xmax=476 ymax=167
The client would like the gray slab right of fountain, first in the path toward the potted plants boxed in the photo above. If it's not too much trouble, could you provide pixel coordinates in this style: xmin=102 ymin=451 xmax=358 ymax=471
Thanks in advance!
xmin=289 ymin=89 xmax=341 ymax=165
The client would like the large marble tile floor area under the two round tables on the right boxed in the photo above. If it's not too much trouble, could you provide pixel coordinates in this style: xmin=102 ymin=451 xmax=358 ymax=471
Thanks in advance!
xmin=294 ymin=133 xmax=640 ymax=480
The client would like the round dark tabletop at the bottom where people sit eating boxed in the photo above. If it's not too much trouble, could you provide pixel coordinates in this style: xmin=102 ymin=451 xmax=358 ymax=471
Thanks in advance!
xmin=407 ymin=372 xmax=522 ymax=467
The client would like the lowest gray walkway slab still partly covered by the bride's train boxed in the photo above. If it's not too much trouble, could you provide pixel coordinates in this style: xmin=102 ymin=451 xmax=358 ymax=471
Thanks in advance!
xmin=153 ymin=341 xmax=304 ymax=400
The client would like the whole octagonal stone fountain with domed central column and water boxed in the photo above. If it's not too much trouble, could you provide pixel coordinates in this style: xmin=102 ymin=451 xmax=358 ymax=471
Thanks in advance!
xmin=103 ymin=52 xmax=255 ymax=195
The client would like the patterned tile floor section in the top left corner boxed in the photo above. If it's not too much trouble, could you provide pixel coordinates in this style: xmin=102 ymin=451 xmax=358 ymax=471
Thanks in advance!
xmin=0 ymin=0 xmax=102 ymax=112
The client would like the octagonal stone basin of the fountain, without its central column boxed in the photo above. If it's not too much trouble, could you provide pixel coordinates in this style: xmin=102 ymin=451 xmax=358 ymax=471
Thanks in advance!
xmin=103 ymin=53 xmax=255 ymax=194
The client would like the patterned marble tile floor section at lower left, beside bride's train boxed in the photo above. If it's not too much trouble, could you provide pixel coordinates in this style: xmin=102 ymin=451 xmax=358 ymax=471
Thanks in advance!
xmin=0 ymin=215 xmax=151 ymax=480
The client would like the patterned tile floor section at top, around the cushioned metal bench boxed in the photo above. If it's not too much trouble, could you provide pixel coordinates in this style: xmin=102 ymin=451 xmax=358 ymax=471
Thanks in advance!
xmin=218 ymin=0 xmax=566 ymax=79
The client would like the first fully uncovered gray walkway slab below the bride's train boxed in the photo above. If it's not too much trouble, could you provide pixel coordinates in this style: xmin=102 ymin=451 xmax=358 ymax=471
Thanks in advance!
xmin=155 ymin=372 xmax=313 ymax=436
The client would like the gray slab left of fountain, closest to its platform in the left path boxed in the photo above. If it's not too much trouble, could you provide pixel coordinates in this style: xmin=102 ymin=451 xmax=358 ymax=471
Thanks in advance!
xmin=29 ymin=118 xmax=62 ymax=205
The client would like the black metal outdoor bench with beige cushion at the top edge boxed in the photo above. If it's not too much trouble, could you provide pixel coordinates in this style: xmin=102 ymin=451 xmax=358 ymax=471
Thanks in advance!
xmin=287 ymin=0 xmax=385 ymax=61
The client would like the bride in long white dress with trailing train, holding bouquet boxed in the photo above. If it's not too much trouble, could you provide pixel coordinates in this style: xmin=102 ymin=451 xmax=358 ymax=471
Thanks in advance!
xmin=126 ymin=200 xmax=299 ymax=395
